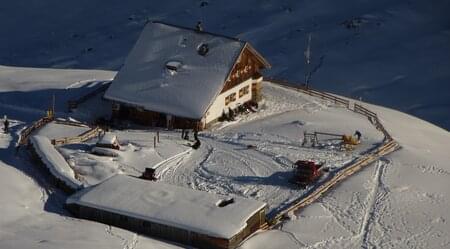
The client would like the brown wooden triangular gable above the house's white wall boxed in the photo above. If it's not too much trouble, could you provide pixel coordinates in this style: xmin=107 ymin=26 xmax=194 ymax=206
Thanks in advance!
xmin=221 ymin=46 xmax=265 ymax=93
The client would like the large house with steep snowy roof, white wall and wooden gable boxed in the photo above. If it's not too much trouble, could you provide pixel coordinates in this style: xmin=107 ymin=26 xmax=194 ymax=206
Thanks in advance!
xmin=104 ymin=22 xmax=270 ymax=130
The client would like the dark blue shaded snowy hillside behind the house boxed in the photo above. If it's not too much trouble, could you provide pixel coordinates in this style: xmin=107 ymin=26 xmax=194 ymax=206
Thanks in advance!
xmin=0 ymin=0 xmax=450 ymax=130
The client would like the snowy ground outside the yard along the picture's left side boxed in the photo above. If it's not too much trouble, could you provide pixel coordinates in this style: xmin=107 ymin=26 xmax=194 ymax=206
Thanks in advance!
xmin=0 ymin=67 xmax=185 ymax=249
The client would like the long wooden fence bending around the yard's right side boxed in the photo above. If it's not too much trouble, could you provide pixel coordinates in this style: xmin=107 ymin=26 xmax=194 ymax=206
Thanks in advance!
xmin=261 ymin=79 xmax=400 ymax=229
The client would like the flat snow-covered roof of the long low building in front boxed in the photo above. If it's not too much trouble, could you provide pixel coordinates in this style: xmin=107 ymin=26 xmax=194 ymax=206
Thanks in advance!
xmin=66 ymin=175 xmax=266 ymax=239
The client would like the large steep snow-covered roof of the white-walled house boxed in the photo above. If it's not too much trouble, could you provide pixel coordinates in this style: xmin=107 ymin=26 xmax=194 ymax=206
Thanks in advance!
xmin=104 ymin=22 xmax=246 ymax=119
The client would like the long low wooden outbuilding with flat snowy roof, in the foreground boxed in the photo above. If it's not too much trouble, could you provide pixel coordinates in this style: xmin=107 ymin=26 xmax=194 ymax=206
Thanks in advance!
xmin=66 ymin=175 xmax=266 ymax=249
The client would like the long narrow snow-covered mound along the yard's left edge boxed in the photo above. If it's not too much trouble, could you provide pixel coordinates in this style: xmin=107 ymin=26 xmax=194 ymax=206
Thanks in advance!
xmin=31 ymin=135 xmax=83 ymax=189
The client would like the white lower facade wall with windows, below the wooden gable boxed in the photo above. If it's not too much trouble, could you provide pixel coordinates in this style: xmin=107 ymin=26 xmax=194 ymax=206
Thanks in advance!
xmin=204 ymin=78 xmax=258 ymax=124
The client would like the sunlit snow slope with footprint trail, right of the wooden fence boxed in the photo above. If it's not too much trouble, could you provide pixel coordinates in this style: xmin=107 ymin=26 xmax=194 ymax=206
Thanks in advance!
xmin=242 ymin=106 xmax=450 ymax=249
